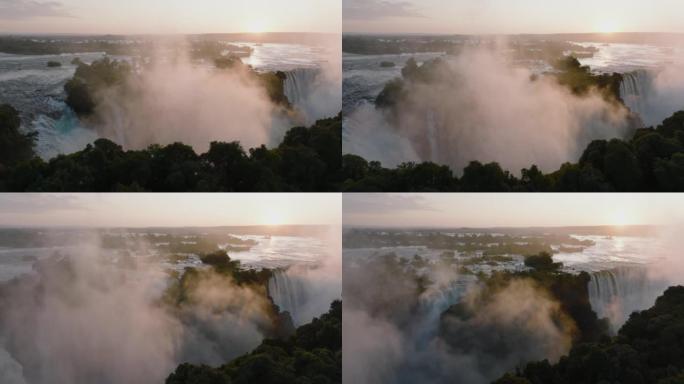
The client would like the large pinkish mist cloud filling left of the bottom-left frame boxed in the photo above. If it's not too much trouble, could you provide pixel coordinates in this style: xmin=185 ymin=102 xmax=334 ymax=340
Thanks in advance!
xmin=0 ymin=237 xmax=316 ymax=384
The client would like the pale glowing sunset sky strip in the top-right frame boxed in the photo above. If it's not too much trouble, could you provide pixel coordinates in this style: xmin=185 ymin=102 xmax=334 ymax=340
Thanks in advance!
xmin=342 ymin=0 xmax=684 ymax=34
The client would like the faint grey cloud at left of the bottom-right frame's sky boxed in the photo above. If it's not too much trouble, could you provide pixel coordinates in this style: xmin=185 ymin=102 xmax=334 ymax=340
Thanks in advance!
xmin=343 ymin=194 xmax=435 ymax=214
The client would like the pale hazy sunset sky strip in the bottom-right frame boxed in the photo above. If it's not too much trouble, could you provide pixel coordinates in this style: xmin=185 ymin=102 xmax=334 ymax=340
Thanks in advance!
xmin=343 ymin=193 xmax=684 ymax=228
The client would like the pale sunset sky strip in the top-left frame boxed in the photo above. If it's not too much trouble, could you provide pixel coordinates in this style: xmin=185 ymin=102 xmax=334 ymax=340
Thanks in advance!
xmin=0 ymin=0 xmax=342 ymax=34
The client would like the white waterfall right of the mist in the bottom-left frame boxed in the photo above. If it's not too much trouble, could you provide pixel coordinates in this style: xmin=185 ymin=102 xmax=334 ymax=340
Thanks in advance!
xmin=268 ymin=270 xmax=308 ymax=325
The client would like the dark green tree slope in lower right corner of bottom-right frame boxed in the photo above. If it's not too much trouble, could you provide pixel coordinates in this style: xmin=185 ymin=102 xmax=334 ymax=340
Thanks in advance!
xmin=495 ymin=286 xmax=684 ymax=384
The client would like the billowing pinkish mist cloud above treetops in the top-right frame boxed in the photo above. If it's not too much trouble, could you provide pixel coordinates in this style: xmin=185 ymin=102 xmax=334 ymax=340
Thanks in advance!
xmin=344 ymin=49 xmax=631 ymax=172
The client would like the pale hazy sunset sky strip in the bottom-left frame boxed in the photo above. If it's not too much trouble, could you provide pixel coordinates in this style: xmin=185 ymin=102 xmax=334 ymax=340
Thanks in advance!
xmin=0 ymin=193 xmax=342 ymax=228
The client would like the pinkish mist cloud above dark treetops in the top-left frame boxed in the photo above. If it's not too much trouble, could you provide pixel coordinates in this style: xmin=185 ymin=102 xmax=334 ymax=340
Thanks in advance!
xmin=95 ymin=60 xmax=289 ymax=151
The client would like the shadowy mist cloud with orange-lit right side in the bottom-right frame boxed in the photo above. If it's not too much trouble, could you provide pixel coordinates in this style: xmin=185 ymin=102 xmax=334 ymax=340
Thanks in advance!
xmin=343 ymin=255 xmax=575 ymax=384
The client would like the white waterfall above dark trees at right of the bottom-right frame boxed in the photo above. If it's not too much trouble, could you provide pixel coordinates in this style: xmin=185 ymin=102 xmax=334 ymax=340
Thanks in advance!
xmin=589 ymin=267 xmax=668 ymax=332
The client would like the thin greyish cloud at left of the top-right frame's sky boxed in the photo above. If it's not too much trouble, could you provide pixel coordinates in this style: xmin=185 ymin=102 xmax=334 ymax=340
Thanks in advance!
xmin=342 ymin=0 xmax=425 ymax=20
